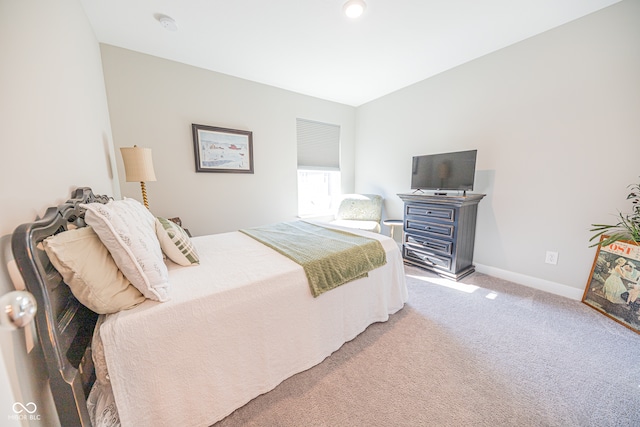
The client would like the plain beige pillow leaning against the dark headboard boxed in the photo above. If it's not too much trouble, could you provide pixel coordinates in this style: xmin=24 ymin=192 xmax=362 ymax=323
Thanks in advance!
xmin=43 ymin=227 xmax=144 ymax=314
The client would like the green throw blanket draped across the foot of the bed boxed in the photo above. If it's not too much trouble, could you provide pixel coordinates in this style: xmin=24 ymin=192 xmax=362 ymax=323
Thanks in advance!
xmin=240 ymin=221 xmax=387 ymax=297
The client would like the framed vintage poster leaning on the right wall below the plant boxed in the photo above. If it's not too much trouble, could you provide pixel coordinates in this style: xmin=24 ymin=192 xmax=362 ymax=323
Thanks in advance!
xmin=582 ymin=236 xmax=640 ymax=333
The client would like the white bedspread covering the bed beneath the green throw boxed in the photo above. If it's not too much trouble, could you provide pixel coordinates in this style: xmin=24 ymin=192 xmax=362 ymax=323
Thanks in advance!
xmin=100 ymin=227 xmax=407 ymax=427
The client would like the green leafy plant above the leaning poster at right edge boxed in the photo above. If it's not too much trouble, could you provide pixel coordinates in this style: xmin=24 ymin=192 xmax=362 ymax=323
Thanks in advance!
xmin=589 ymin=184 xmax=640 ymax=247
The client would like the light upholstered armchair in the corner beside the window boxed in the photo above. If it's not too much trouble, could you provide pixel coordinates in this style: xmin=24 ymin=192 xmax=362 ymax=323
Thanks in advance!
xmin=331 ymin=194 xmax=383 ymax=233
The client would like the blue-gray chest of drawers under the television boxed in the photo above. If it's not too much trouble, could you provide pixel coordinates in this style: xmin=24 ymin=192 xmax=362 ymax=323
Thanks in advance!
xmin=398 ymin=193 xmax=485 ymax=280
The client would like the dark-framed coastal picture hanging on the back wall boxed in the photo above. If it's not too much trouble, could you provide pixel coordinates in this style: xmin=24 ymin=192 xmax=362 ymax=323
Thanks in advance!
xmin=191 ymin=124 xmax=253 ymax=173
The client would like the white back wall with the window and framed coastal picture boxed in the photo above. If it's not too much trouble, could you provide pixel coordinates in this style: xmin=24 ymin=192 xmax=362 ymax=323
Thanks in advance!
xmin=101 ymin=45 xmax=355 ymax=235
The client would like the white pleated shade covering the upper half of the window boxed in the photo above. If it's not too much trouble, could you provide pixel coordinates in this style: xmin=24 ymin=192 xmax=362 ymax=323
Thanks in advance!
xmin=296 ymin=119 xmax=340 ymax=171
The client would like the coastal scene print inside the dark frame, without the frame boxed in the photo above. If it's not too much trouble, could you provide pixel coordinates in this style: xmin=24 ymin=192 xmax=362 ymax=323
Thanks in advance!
xmin=198 ymin=129 xmax=250 ymax=170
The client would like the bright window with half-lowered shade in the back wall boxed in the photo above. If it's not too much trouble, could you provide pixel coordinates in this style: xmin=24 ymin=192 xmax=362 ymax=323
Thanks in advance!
xmin=296 ymin=119 xmax=341 ymax=216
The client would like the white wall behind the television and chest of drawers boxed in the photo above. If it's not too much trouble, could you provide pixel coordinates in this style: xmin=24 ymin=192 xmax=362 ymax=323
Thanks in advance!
xmin=356 ymin=0 xmax=640 ymax=297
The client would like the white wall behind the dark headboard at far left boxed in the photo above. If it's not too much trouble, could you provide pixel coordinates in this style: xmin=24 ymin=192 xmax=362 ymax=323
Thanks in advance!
xmin=0 ymin=0 xmax=119 ymax=426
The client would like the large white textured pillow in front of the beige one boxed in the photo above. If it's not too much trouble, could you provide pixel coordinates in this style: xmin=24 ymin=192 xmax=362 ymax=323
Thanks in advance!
xmin=80 ymin=198 xmax=169 ymax=302
